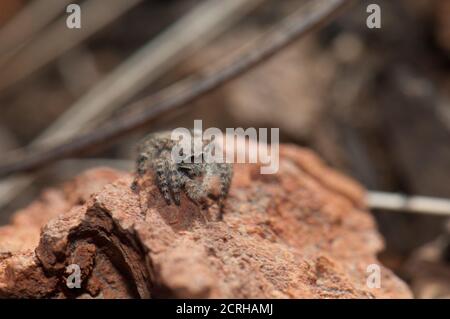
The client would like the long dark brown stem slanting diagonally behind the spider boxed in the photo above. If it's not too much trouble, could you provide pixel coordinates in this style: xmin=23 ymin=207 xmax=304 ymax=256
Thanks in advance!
xmin=0 ymin=0 xmax=351 ymax=177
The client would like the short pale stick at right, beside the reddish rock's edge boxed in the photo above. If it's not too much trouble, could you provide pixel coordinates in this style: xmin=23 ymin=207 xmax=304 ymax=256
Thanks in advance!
xmin=367 ymin=191 xmax=450 ymax=216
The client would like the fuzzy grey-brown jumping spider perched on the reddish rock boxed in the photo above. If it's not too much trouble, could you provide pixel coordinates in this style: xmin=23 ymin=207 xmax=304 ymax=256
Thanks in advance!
xmin=131 ymin=131 xmax=233 ymax=205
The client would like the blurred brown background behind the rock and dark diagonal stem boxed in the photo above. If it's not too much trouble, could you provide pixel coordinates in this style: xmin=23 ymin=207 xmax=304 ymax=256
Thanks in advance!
xmin=0 ymin=0 xmax=450 ymax=298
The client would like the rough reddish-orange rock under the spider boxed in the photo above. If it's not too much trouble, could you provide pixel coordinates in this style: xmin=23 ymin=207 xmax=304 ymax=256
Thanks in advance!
xmin=0 ymin=146 xmax=411 ymax=298
